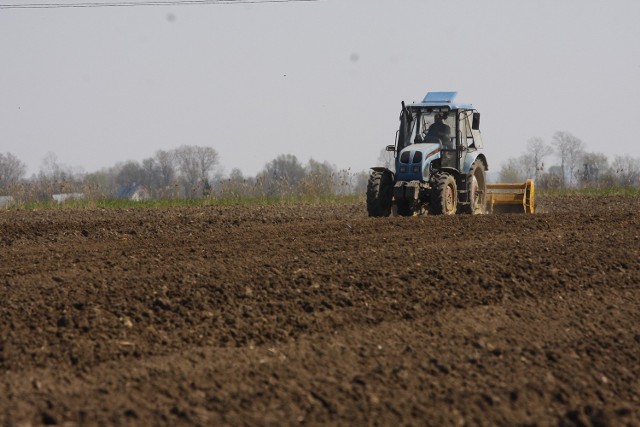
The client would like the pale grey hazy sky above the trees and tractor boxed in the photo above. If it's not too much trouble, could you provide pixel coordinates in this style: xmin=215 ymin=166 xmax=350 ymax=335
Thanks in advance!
xmin=0 ymin=0 xmax=640 ymax=176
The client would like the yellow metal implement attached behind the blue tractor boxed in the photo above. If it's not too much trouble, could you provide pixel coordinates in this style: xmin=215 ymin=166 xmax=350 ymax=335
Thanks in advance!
xmin=487 ymin=179 xmax=535 ymax=214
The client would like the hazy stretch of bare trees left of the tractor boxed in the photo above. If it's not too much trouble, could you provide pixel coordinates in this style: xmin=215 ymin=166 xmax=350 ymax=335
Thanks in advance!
xmin=0 ymin=145 xmax=368 ymax=202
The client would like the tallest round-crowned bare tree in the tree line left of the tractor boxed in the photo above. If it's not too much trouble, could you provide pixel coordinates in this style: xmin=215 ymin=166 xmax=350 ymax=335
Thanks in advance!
xmin=175 ymin=145 xmax=218 ymax=197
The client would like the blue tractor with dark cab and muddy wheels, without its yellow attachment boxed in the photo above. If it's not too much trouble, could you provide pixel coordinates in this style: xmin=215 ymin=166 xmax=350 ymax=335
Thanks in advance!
xmin=367 ymin=92 xmax=488 ymax=217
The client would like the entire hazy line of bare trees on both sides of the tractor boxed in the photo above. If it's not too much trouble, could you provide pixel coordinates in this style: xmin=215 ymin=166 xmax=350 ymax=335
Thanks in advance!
xmin=0 ymin=131 xmax=640 ymax=206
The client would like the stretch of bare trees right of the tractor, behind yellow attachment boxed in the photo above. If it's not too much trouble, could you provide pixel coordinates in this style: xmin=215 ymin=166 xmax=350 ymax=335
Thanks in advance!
xmin=498 ymin=131 xmax=640 ymax=189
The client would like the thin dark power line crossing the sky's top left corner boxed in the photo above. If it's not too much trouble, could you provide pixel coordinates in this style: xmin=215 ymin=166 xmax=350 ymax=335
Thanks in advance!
xmin=0 ymin=0 xmax=319 ymax=9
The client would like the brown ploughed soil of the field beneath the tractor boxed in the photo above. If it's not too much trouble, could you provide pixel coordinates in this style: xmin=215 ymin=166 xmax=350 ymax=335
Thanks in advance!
xmin=0 ymin=197 xmax=640 ymax=426
